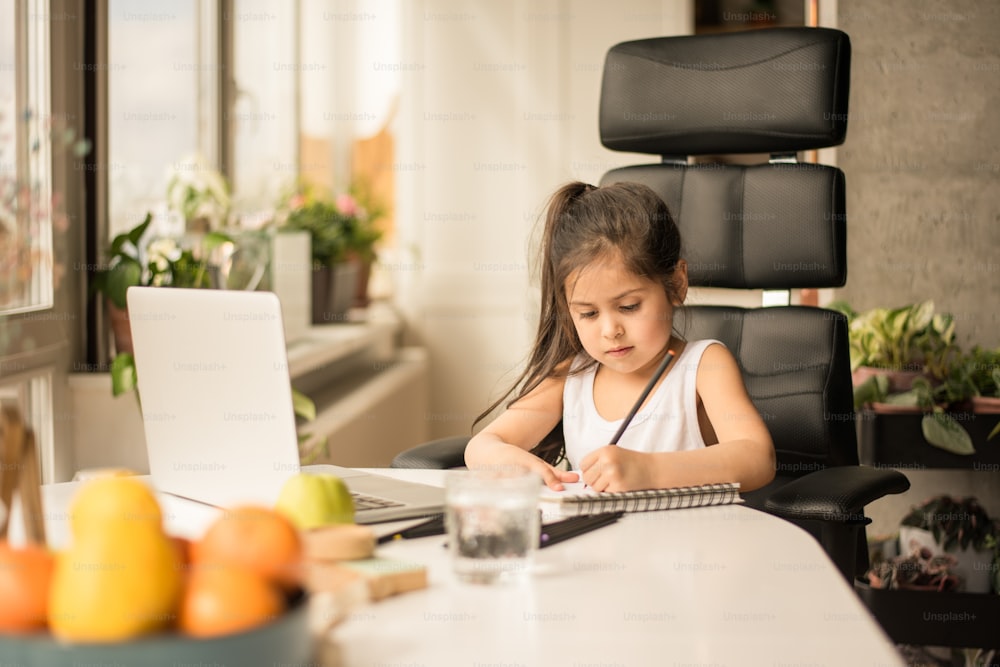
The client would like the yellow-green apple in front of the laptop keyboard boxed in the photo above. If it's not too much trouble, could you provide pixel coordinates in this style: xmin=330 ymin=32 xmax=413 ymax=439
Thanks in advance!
xmin=275 ymin=472 xmax=354 ymax=530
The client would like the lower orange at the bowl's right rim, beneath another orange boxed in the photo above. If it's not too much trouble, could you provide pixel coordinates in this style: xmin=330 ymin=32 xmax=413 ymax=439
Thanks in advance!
xmin=177 ymin=565 xmax=285 ymax=637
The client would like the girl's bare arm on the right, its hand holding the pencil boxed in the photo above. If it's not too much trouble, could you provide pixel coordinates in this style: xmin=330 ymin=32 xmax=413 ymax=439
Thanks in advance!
xmin=580 ymin=345 xmax=775 ymax=491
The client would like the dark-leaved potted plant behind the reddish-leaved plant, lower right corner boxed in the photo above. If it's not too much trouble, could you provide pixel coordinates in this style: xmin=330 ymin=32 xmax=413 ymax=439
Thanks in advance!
xmin=899 ymin=495 xmax=1000 ymax=593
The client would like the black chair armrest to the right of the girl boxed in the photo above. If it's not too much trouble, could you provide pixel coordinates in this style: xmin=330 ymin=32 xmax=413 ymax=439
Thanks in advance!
xmin=764 ymin=466 xmax=910 ymax=523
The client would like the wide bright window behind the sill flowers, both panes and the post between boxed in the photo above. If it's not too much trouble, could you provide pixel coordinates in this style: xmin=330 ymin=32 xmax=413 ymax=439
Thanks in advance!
xmin=101 ymin=0 xmax=399 ymax=238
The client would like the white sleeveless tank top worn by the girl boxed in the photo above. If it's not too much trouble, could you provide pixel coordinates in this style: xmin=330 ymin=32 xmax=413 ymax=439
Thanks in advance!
xmin=563 ymin=340 xmax=722 ymax=470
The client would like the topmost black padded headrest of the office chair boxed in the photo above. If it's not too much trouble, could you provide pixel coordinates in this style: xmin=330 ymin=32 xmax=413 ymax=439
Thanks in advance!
xmin=600 ymin=28 xmax=851 ymax=156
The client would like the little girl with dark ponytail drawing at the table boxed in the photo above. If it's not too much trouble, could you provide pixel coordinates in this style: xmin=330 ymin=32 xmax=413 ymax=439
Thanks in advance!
xmin=465 ymin=183 xmax=774 ymax=491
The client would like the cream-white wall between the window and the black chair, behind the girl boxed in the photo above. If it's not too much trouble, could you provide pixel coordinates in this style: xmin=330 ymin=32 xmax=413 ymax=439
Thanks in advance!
xmin=392 ymin=0 xmax=693 ymax=444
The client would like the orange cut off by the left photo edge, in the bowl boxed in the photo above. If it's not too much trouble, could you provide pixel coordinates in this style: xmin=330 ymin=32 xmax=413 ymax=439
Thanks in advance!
xmin=0 ymin=542 xmax=55 ymax=633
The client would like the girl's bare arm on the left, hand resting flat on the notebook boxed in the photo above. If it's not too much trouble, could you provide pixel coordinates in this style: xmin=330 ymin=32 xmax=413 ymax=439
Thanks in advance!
xmin=465 ymin=378 xmax=577 ymax=491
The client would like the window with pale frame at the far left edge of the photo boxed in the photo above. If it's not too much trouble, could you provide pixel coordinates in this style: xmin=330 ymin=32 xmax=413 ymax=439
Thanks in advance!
xmin=0 ymin=0 xmax=85 ymax=482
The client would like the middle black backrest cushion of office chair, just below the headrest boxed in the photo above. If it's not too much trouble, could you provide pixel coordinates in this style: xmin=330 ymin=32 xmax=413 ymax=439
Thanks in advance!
xmin=601 ymin=163 xmax=847 ymax=289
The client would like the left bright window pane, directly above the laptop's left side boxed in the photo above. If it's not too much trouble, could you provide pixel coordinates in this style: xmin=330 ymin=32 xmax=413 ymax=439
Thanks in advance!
xmin=107 ymin=0 xmax=219 ymax=238
